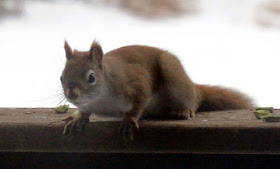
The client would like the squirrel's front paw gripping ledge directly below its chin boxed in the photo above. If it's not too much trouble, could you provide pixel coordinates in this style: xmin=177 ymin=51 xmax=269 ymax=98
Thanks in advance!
xmin=63 ymin=111 xmax=89 ymax=135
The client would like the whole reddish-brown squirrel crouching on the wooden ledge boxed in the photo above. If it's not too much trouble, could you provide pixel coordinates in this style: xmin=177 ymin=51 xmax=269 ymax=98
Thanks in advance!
xmin=60 ymin=41 xmax=253 ymax=142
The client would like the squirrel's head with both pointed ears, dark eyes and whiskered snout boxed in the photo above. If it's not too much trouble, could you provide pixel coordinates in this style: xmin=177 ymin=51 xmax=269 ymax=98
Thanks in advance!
xmin=60 ymin=41 xmax=104 ymax=107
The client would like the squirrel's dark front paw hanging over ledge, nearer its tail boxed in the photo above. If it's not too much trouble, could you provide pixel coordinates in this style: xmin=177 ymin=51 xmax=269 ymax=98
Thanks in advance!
xmin=120 ymin=118 xmax=139 ymax=145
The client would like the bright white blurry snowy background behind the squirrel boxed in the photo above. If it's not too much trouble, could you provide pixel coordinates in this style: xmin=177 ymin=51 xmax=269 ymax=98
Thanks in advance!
xmin=0 ymin=0 xmax=280 ymax=108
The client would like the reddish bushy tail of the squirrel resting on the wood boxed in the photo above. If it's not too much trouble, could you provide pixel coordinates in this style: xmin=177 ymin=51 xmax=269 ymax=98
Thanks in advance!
xmin=196 ymin=85 xmax=253 ymax=112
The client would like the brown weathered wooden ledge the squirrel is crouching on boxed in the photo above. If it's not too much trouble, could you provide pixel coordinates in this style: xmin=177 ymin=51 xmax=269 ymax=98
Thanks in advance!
xmin=0 ymin=108 xmax=280 ymax=154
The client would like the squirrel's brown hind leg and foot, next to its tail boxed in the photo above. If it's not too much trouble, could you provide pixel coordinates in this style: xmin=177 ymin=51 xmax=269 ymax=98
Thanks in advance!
xmin=159 ymin=52 xmax=199 ymax=119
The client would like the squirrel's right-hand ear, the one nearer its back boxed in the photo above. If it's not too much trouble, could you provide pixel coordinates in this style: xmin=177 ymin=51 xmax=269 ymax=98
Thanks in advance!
xmin=89 ymin=41 xmax=103 ymax=69
